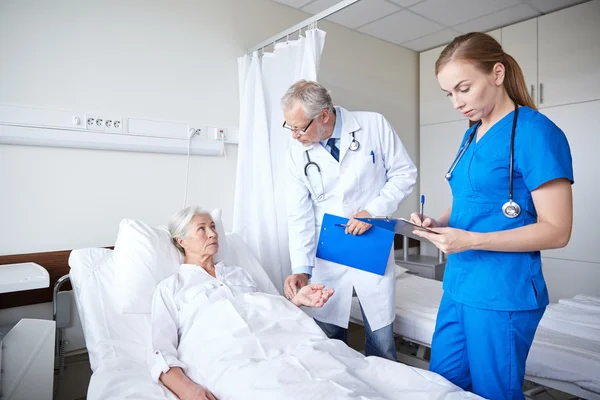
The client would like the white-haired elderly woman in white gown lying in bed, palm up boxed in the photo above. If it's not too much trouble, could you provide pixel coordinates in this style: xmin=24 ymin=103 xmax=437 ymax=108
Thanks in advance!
xmin=151 ymin=207 xmax=334 ymax=399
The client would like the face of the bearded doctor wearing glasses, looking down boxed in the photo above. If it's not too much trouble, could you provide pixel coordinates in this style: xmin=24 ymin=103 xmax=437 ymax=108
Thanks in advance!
xmin=283 ymin=101 xmax=329 ymax=146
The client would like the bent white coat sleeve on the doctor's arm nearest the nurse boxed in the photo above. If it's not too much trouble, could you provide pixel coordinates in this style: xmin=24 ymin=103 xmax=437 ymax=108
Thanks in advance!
xmin=365 ymin=117 xmax=417 ymax=217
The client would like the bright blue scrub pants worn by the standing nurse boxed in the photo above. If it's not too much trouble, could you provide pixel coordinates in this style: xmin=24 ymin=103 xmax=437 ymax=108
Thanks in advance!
xmin=429 ymin=294 xmax=546 ymax=400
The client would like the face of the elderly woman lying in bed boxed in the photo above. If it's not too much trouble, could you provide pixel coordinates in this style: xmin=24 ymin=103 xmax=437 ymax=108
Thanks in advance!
xmin=181 ymin=214 xmax=219 ymax=257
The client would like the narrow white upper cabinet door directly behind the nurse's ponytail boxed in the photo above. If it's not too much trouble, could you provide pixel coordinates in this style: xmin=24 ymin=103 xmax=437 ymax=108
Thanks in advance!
xmin=502 ymin=18 xmax=539 ymax=105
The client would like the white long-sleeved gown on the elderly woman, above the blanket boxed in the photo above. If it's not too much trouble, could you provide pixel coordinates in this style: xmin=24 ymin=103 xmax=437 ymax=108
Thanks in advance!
xmin=150 ymin=262 xmax=257 ymax=382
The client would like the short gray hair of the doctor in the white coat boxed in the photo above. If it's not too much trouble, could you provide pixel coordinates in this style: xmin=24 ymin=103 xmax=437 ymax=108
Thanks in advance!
xmin=281 ymin=79 xmax=333 ymax=119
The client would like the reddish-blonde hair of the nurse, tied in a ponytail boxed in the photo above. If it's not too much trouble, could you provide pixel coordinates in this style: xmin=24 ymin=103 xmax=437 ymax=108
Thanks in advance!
xmin=435 ymin=32 xmax=537 ymax=110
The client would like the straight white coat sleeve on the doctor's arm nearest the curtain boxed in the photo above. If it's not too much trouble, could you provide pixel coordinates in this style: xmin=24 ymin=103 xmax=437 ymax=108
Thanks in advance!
xmin=285 ymin=150 xmax=317 ymax=275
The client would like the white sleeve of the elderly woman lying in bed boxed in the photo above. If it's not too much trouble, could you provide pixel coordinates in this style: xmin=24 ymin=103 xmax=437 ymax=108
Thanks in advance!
xmin=150 ymin=279 xmax=185 ymax=382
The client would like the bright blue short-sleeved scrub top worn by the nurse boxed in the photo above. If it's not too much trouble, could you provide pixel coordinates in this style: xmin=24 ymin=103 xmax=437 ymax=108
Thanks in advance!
xmin=444 ymin=107 xmax=573 ymax=311
